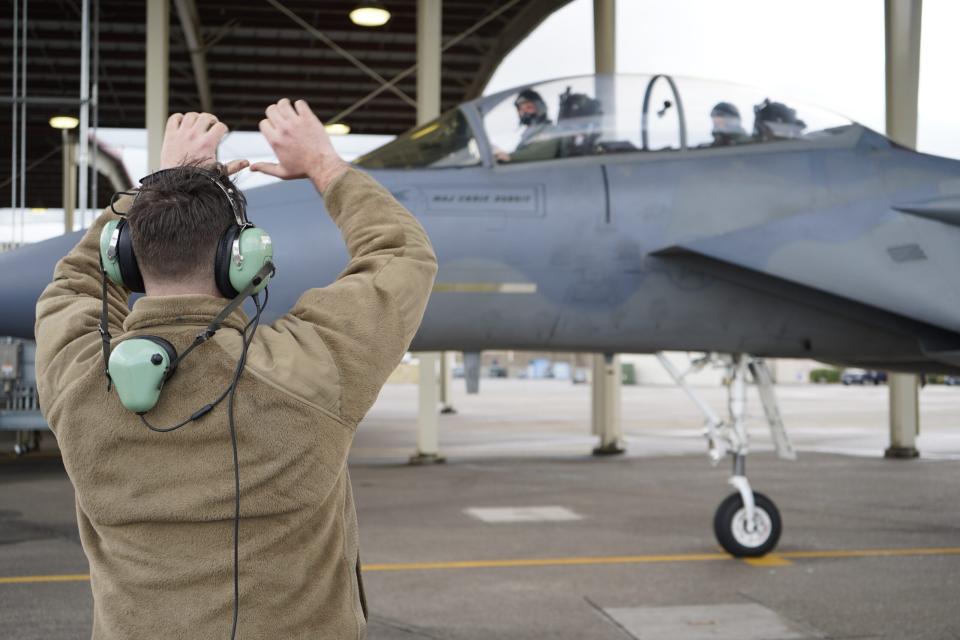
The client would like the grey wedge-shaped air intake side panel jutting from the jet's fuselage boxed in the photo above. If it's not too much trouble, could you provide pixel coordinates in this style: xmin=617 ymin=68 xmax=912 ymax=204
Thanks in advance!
xmin=652 ymin=203 xmax=960 ymax=332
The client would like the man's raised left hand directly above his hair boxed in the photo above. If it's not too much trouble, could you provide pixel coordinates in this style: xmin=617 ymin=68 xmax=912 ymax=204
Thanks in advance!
xmin=160 ymin=111 xmax=250 ymax=174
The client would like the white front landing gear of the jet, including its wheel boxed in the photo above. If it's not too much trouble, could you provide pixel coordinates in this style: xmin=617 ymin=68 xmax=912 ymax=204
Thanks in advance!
xmin=657 ymin=353 xmax=797 ymax=558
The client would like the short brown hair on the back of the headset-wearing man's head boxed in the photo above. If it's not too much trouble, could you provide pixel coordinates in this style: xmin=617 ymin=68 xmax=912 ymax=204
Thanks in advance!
xmin=127 ymin=164 xmax=246 ymax=280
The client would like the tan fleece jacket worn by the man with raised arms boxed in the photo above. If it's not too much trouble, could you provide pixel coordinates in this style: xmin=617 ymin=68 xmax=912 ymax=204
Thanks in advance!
xmin=36 ymin=169 xmax=436 ymax=640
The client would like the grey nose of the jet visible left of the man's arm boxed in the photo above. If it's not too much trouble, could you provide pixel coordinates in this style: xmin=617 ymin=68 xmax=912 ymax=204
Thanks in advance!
xmin=0 ymin=232 xmax=81 ymax=339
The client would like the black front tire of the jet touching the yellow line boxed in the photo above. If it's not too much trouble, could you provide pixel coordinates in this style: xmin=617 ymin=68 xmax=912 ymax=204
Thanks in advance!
xmin=713 ymin=493 xmax=783 ymax=558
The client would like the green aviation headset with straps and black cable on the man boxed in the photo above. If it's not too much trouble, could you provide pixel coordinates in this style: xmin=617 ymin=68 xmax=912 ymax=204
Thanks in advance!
xmin=99 ymin=167 xmax=276 ymax=639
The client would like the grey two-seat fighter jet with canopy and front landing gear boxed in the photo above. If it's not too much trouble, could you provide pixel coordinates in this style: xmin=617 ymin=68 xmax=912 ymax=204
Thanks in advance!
xmin=0 ymin=75 xmax=960 ymax=556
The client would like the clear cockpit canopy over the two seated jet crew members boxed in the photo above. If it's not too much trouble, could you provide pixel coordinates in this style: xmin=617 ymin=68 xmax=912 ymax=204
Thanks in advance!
xmin=357 ymin=74 xmax=854 ymax=169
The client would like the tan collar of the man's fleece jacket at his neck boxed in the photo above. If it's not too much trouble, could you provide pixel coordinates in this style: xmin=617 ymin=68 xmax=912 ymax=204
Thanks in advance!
xmin=123 ymin=294 xmax=247 ymax=332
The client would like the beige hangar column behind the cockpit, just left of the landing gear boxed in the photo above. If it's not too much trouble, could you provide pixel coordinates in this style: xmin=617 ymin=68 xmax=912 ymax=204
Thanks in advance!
xmin=590 ymin=0 xmax=624 ymax=455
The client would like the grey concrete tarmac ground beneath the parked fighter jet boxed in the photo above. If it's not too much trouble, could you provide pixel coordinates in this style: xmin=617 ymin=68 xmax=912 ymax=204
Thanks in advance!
xmin=0 ymin=380 xmax=960 ymax=640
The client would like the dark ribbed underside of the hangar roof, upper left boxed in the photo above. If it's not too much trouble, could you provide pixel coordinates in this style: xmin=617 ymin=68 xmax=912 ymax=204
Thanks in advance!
xmin=0 ymin=0 xmax=569 ymax=207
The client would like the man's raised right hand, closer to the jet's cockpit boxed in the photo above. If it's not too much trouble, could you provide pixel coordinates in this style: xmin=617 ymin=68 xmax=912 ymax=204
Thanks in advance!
xmin=250 ymin=98 xmax=349 ymax=192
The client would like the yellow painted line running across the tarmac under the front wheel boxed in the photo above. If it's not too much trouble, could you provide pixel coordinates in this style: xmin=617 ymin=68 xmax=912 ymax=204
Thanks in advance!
xmin=0 ymin=547 xmax=960 ymax=585
